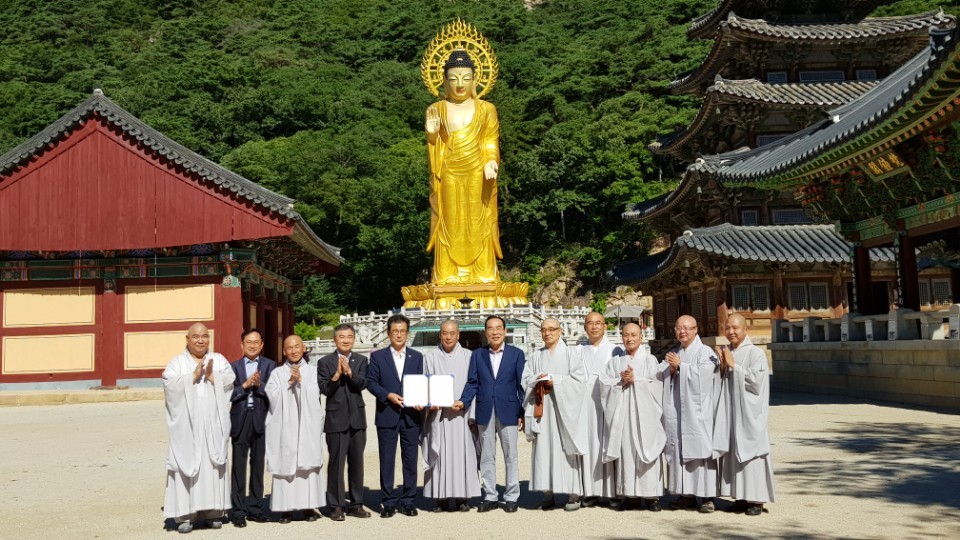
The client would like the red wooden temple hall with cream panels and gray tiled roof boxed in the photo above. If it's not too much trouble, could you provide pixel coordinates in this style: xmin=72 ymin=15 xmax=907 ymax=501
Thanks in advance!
xmin=0 ymin=90 xmax=343 ymax=389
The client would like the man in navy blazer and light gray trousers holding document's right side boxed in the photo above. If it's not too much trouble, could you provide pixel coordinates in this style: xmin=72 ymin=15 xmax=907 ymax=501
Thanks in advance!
xmin=454 ymin=315 xmax=526 ymax=512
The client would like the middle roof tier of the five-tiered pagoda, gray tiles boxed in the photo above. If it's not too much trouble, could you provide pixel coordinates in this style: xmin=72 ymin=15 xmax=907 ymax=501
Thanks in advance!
xmin=648 ymin=77 xmax=877 ymax=158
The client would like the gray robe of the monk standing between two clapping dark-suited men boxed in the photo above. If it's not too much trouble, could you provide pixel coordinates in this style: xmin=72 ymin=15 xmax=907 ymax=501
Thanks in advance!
xmin=264 ymin=360 xmax=327 ymax=512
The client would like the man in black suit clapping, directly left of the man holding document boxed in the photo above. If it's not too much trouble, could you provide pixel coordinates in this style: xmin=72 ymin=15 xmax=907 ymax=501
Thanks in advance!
xmin=317 ymin=324 xmax=370 ymax=521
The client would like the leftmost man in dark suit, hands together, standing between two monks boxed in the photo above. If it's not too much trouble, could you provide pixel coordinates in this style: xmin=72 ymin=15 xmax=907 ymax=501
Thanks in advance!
xmin=230 ymin=328 xmax=277 ymax=527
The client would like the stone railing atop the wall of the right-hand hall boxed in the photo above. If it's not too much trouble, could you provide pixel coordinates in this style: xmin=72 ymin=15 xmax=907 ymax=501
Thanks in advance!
xmin=771 ymin=304 xmax=960 ymax=343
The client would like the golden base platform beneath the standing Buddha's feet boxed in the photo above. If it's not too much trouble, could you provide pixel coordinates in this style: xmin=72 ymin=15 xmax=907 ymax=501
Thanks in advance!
xmin=400 ymin=281 xmax=530 ymax=309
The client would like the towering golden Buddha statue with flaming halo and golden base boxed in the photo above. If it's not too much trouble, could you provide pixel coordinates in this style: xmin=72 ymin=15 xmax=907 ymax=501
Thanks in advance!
xmin=402 ymin=20 xmax=528 ymax=309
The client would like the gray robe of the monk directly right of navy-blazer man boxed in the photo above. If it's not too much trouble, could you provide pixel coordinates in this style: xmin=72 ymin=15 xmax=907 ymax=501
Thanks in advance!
xmin=523 ymin=342 xmax=585 ymax=495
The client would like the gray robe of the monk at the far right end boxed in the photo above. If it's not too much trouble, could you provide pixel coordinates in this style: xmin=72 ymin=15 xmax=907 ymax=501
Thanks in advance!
xmin=714 ymin=337 xmax=774 ymax=503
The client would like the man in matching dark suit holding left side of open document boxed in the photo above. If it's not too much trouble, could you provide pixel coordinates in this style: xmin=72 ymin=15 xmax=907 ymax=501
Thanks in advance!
xmin=367 ymin=315 xmax=423 ymax=518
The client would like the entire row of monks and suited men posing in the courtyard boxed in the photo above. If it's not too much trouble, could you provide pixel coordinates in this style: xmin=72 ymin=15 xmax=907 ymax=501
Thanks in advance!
xmin=163 ymin=312 xmax=774 ymax=533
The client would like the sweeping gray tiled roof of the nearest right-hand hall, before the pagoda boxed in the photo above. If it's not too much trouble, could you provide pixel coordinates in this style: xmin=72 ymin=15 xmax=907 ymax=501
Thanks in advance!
xmin=713 ymin=30 xmax=960 ymax=188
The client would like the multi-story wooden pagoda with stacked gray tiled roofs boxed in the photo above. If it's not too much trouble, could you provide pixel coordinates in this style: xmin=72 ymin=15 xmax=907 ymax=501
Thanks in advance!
xmin=614 ymin=0 xmax=954 ymax=348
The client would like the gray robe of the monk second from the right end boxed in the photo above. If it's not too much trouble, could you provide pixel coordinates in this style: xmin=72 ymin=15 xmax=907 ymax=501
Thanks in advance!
xmin=657 ymin=336 xmax=720 ymax=497
